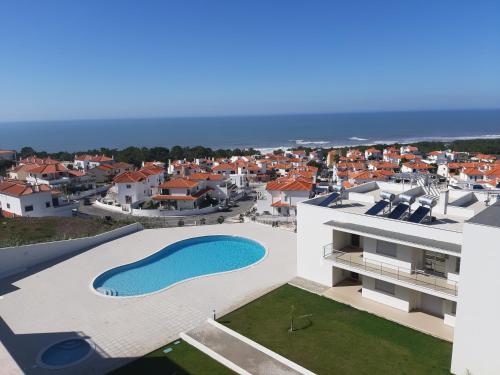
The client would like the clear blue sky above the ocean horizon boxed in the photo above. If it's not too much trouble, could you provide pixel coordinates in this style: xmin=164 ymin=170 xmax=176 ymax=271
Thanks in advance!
xmin=0 ymin=0 xmax=500 ymax=121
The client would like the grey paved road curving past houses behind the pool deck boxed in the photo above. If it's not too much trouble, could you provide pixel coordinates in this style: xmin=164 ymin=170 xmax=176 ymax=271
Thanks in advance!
xmin=79 ymin=197 xmax=255 ymax=227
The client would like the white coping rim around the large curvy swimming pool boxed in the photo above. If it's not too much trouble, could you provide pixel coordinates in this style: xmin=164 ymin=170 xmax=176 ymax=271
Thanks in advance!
xmin=89 ymin=234 xmax=269 ymax=300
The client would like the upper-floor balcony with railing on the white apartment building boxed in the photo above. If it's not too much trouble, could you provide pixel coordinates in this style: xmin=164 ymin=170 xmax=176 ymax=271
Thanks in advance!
xmin=323 ymin=244 xmax=458 ymax=296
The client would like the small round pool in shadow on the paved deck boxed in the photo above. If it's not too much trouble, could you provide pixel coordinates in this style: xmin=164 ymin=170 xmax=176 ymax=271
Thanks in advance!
xmin=38 ymin=338 xmax=93 ymax=368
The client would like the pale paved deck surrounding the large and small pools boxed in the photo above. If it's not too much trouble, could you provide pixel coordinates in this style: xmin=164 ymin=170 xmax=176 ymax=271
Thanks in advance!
xmin=0 ymin=223 xmax=296 ymax=374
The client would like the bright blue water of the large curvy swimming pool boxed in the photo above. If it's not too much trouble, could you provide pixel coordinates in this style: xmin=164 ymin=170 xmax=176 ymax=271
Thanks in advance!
xmin=93 ymin=235 xmax=266 ymax=296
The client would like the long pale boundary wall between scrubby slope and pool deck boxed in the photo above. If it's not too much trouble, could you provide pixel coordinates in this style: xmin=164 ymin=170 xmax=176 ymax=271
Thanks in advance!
xmin=0 ymin=223 xmax=142 ymax=278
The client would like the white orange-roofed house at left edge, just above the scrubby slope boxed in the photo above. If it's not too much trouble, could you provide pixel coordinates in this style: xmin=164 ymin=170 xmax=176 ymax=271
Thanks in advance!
xmin=0 ymin=180 xmax=78 ymax=217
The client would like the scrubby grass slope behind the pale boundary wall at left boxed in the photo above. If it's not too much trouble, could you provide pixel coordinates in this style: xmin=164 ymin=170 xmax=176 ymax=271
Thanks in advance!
xmin=0 ymin=217 xmax=129 ymax=248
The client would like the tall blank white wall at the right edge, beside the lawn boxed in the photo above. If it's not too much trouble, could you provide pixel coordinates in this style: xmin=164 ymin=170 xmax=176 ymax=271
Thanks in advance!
xmin=451 ymin=223 xmax=500 ymax=375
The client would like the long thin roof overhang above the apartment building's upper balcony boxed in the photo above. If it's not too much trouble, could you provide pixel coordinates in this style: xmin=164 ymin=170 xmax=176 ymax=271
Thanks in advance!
xmin=324 ymin=219 xmax=460 ymax=253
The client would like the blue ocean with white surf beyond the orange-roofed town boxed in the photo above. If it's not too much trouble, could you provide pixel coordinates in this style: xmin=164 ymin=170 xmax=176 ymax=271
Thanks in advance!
xmin=0 ymin=109 xmax=500 ymax=152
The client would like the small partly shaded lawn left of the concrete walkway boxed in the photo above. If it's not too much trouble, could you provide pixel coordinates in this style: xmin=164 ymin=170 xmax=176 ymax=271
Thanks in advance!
xmin=112 ymin=340 xmax=234 ymax=375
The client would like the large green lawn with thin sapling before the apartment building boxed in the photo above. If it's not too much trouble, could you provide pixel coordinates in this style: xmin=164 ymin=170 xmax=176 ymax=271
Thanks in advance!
xmin=219 ymin=285 xmax=452 ymax=375
